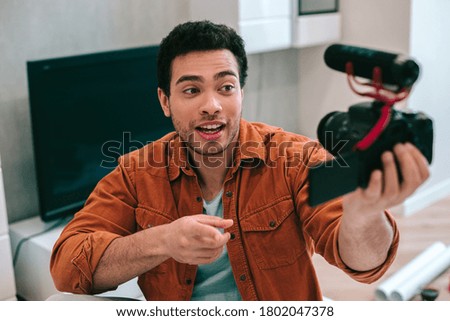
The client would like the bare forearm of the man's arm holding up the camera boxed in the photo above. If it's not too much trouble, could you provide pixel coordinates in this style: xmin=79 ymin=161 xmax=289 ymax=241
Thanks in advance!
xmin=338 ymin=212 xmax=394 ymax=271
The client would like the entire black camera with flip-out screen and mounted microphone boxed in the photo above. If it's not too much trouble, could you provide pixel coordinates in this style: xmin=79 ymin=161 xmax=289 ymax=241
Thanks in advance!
xmin=309 ymin=44 xmax=433 ymax=206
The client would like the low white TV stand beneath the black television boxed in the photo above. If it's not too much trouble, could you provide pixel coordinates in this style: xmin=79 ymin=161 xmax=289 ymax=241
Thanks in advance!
xmin=9 ymin=216 xmax=144 ymax=301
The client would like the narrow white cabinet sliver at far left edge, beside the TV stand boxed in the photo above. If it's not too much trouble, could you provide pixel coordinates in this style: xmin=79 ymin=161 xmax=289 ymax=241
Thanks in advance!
xmin=0 ymin=159 xmax=16 ymax=300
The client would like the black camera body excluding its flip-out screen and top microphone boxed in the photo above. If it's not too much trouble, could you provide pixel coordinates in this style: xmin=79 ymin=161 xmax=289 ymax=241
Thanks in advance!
xmin=317 ymin=101 xmax=433 ymax=182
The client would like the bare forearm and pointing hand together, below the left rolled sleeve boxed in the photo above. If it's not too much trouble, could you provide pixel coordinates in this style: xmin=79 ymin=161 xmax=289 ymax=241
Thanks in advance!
xmin=93 ymin=214 xmax=233 ymax=292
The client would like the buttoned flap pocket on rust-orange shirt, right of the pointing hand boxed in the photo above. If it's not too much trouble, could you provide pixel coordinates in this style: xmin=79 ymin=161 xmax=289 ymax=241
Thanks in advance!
xmin=240 ymin=196 xmax=306 ymax=270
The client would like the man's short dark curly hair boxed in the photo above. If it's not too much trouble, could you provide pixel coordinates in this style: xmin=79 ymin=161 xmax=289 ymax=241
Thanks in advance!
xmin=158 ymin=20 xmax=248 ymax=96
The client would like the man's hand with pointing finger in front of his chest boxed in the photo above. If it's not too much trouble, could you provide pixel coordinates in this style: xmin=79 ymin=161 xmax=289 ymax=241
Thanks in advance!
xmin=163 ymin=214 xmax=233 ymax=264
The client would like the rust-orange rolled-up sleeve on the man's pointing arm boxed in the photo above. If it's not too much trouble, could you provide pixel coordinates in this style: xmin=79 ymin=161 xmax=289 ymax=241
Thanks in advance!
xmin=50 ymin=156 xmax=136 ymax=294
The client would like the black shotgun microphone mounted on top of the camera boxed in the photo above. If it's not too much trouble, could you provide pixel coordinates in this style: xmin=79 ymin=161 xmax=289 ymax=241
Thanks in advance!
xmin=324 ymin=44 xmax=419 ymax=89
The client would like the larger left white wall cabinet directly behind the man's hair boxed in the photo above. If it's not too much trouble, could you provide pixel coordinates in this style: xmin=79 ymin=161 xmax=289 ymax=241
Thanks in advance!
xmin=189 ymin=0 xmax=292 ymax=54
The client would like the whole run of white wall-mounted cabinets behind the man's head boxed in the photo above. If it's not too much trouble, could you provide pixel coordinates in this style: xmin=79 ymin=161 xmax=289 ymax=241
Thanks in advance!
xmin=189 ymin=0 xmax=341 ymax=54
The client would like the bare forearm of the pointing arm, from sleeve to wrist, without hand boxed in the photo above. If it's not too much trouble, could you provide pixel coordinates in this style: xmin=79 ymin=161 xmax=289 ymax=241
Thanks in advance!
xmin=93 ymin=227 xmax=169 ymax=292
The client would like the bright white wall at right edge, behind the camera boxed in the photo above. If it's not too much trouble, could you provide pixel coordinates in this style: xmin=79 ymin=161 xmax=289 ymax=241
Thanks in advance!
xmin=404 ymin=0 xmax=450 ymax=212
